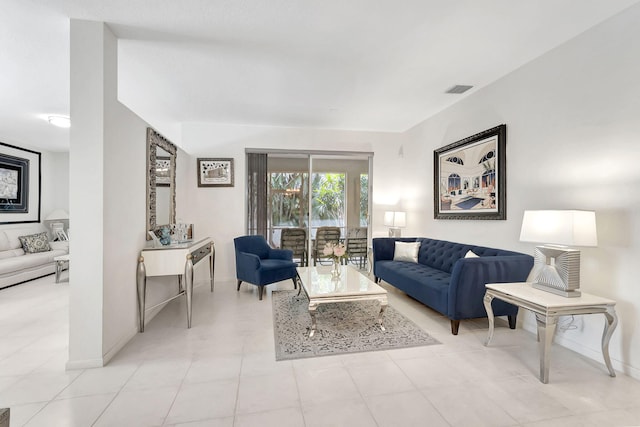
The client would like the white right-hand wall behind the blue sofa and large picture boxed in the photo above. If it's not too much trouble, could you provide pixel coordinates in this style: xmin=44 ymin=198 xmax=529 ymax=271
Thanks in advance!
xmin=400 ymin=6 xmax=640 ymax=378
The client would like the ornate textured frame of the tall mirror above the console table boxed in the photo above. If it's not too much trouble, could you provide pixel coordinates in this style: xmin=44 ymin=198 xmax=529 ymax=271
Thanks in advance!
xmin=145 ymin=128 xmax=178 ymax=240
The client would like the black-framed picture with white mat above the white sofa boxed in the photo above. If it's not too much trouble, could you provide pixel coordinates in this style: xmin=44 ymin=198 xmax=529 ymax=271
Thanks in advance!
xmin=0 ymin=143 xmax=40 ymax=224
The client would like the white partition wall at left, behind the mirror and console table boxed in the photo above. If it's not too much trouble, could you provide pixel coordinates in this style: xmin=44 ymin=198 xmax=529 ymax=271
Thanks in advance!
xmin=67 ymin=20 xmax=186 ymax=368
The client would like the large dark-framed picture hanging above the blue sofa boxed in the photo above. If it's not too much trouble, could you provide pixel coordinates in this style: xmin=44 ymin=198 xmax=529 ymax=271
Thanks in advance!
xmin=433 ymin=124 xmax=507 ymax=220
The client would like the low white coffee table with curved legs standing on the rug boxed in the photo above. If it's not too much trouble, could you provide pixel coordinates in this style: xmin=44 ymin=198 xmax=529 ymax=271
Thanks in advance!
xmin=297 ymin=265 xmax=388 ymax=338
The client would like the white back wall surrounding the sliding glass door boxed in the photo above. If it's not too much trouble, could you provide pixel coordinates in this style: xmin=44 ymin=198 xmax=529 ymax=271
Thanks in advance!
xmin=182 ymin=124 xmax=404 ymax=281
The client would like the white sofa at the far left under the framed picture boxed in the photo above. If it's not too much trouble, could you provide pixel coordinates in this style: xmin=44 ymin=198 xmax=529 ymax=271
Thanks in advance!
xmin=0 ymin=224 xmax=69 ymax=289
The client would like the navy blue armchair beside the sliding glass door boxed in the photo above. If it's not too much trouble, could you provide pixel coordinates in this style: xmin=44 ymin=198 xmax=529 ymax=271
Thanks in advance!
xmin=233 ymin=236 xmax=297 ymax=300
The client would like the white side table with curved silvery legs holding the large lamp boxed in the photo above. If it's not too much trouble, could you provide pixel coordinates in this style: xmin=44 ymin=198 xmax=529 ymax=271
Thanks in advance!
xmin=484 ymin=283 xmax=618 ymax=384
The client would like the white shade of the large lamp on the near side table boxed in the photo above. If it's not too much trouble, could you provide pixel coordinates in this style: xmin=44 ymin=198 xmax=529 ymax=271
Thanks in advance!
xmin=520 ymin=210 xmax=598 ymax=246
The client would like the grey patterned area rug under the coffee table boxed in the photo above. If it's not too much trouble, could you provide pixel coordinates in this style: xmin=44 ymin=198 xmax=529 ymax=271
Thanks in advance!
xmin=272 ymin=291 xmax=440 ymax=360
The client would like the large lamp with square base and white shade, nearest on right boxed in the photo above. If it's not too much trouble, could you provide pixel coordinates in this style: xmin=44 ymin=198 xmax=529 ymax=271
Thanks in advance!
xmin=520 ymin=210 xmax=598 ymax=297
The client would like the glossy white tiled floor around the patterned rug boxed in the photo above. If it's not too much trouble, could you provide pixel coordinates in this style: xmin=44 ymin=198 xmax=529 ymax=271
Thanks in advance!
xmin=0 ymin=276 xmax=640 ymax=427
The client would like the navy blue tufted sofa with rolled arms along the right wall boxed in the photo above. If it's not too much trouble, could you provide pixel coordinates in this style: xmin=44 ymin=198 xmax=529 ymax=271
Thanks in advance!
xmin=373 ymin=237 xmax=533 ymax=335
